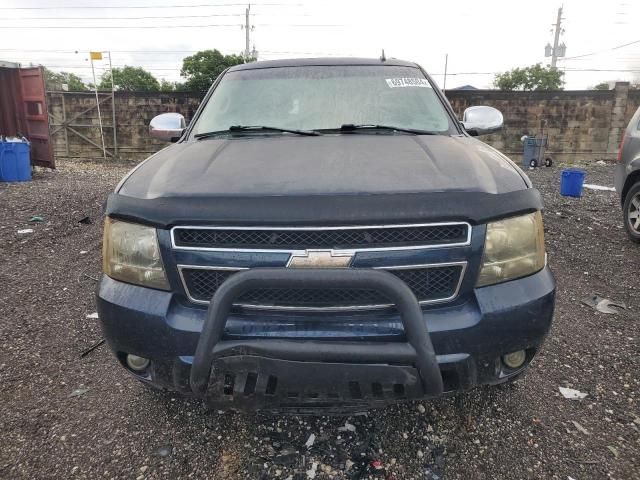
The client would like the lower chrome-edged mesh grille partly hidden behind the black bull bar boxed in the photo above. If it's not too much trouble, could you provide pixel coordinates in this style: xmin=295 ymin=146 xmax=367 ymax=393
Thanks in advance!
xmin=180 ymin=263 xmax=465 ymax=309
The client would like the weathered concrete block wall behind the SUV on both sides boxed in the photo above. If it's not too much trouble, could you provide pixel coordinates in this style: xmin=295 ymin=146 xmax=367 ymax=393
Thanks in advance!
xmin=49 ymin=83 xmax=640 ymax=167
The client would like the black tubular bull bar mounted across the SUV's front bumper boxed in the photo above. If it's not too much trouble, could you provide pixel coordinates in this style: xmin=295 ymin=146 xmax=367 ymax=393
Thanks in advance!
xmin=190 ymin=268 xmax=443 ymax=410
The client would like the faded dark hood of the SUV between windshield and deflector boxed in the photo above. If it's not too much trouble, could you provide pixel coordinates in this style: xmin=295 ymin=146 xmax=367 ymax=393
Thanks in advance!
xmin=118 ymin=133 xmax=530 ymax=199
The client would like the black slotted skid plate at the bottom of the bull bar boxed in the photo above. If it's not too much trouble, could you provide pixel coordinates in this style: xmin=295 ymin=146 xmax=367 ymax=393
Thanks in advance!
xmin=204 ymin=355 xmax=425 ymax=412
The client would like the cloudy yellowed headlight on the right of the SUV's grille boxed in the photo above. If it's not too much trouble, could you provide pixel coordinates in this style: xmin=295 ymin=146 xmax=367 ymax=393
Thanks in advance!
xmin=477 ymin=212 xmax=545 ymax=287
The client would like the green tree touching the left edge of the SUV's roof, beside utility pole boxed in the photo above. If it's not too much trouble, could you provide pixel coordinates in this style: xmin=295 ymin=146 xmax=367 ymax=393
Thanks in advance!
xmin=180 ymin=50 xmax=253 ymax=92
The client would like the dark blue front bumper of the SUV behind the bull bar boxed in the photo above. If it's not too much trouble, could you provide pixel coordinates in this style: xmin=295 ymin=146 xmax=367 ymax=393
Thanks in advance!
xmin=98 ymin=268 xmax=555 ymax=410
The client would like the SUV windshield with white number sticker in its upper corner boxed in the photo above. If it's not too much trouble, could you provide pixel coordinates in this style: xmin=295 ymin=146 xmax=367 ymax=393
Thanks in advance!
xmin=193 ymin=65 xmax=454 ymax=134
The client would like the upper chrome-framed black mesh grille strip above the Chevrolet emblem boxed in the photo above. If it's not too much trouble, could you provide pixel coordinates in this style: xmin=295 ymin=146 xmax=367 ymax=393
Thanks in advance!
xmin=173 ymin=223 xmax=470 ymax=250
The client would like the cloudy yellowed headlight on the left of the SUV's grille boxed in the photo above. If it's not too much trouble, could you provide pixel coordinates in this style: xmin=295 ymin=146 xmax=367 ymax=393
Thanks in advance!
xmin=102 ymin=217 xmax=169 ymax=290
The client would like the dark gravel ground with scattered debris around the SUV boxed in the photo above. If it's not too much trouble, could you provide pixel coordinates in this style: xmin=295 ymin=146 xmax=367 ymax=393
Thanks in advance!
xmin=0 ymin=159 xmax=640 ymax=480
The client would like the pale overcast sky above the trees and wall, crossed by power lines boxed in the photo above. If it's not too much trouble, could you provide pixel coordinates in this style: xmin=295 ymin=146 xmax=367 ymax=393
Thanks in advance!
xmin=0 ymin=0 xmax=640 ymax=89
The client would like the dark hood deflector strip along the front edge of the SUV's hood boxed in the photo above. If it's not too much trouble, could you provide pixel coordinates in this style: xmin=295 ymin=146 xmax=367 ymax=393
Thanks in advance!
xmin=105 ymin=188 xmax=542 ymax=228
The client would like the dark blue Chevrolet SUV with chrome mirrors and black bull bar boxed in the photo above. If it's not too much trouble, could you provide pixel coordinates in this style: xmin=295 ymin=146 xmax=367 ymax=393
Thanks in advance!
xmin=97 ymin=58 xmax=555 ymax=412
